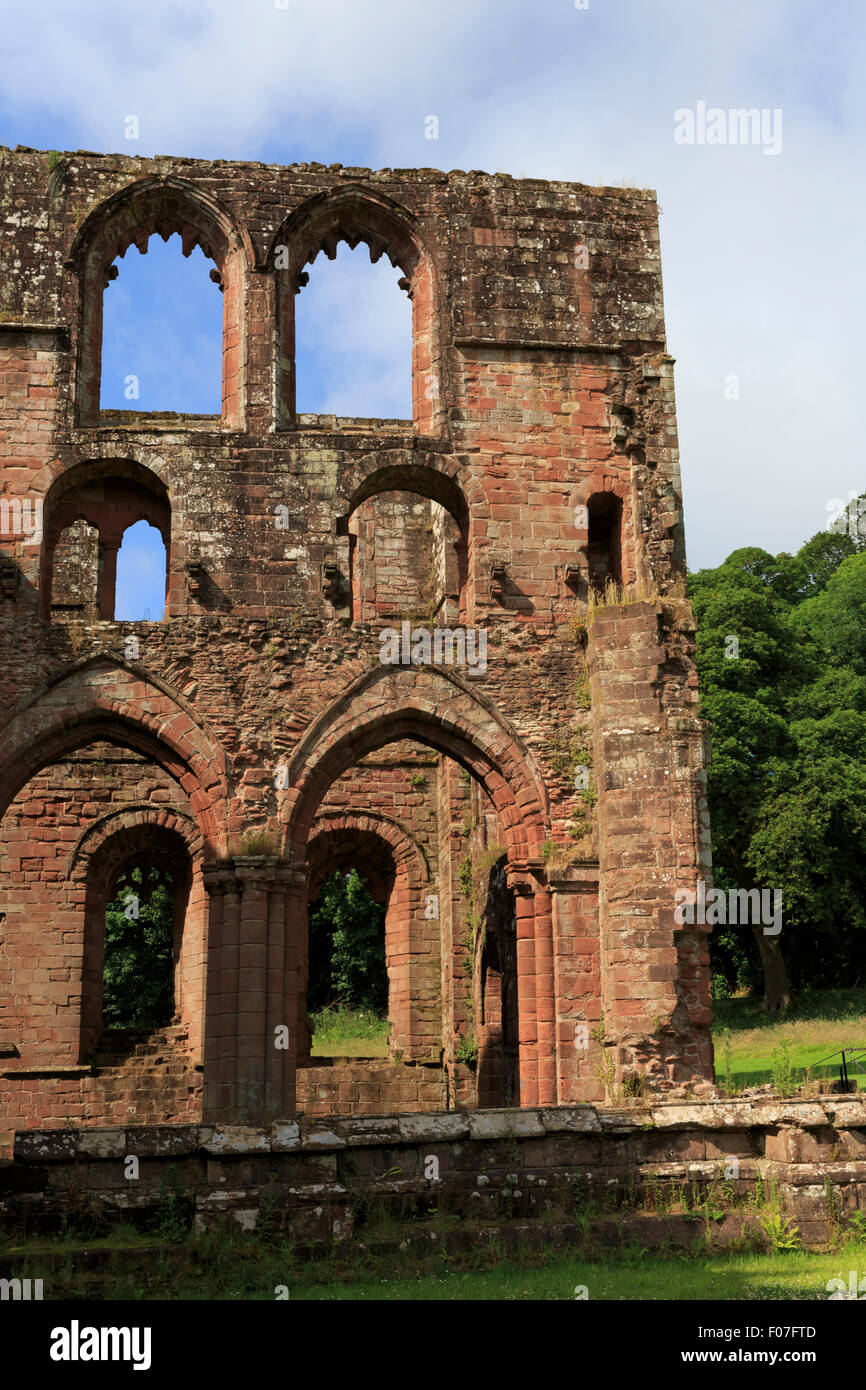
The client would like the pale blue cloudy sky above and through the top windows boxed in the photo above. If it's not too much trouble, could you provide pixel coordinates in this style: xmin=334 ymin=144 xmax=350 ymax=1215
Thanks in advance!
xmin=0 ymin=0 xmax=866 ymax=612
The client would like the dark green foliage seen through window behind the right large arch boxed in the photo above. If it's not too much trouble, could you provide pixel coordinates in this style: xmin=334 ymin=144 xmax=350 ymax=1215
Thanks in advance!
xmin=307 ymin=869 xmax=388 ymax=1013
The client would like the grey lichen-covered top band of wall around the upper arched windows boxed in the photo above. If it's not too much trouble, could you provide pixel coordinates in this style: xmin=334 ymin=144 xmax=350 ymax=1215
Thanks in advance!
xmin=0 ymin=146 xmax=664 ymax=352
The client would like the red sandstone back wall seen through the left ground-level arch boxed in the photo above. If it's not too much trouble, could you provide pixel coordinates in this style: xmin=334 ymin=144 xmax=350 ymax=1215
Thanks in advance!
xmin=0 ymin=742 xmax=206 ymax=1127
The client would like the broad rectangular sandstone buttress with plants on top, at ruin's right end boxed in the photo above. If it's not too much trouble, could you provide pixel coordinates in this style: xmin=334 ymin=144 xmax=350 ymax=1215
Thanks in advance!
xmin=587 ymin=600 xmax=713 ymax=1098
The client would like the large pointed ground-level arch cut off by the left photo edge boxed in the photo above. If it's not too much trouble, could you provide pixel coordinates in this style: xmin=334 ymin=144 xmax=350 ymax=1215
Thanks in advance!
xmin=0 ymin=657 xmax=224 ymax=1122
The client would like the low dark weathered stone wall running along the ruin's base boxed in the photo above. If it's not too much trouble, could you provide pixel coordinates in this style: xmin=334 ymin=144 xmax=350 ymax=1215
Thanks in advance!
xmin=0 ymin=1095 xmax=866 ymax=1245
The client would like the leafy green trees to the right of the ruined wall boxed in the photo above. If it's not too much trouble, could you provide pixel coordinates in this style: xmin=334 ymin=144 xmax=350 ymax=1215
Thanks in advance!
xmin=689 ymin=528 xmax=866 ymax=1009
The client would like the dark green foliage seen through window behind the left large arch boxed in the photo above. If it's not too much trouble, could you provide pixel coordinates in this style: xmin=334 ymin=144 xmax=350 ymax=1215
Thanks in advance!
xmin=103 ymin=866 xmax=174 ymax=1029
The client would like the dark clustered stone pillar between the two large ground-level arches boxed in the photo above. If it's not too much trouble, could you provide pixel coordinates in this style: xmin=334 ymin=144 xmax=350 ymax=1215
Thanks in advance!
xmin=203 ymin=856 xmax=303 ymax=1125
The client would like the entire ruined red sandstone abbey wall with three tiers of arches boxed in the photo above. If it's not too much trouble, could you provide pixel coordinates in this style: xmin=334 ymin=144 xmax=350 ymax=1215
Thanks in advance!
xmin=0 ymin=149 xmax=713 ymax=1129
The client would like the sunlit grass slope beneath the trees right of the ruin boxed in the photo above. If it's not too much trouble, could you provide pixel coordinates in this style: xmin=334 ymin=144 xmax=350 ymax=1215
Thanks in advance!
xmin=713 ymin=990 xmax=866 ymax=1090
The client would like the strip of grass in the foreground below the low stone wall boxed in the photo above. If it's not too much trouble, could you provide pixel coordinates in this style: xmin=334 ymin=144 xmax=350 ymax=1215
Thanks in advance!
xmin=7 ymin=1237 xmax=866 ymax=1302
